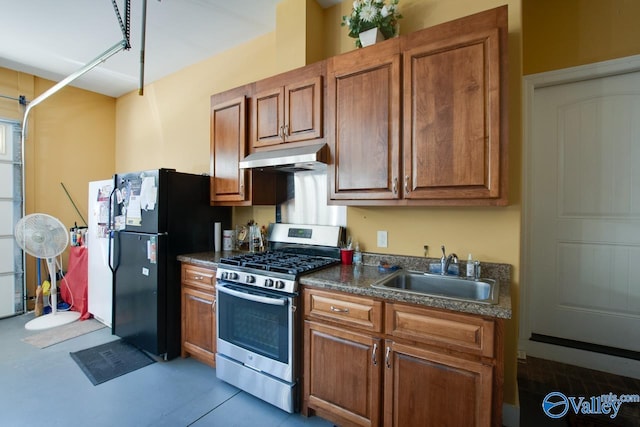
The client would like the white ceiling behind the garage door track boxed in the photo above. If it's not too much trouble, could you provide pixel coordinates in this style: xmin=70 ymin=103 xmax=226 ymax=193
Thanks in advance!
xmin=0 ymin=0 xmax=340 ymax=97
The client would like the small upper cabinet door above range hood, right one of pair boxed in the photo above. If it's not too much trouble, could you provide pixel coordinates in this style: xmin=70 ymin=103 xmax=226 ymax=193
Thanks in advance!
xmin=284 ymin=76 xmax=322 ymax=142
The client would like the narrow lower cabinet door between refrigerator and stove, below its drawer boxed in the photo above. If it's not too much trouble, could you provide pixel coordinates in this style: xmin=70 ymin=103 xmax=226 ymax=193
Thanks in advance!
xmin=182 ymin=285 xmax=216 ymax=366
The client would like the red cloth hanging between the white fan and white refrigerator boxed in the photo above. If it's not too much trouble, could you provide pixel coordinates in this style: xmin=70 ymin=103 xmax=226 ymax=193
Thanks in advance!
xmin=59 ymin=246 xmax=91 ymax=320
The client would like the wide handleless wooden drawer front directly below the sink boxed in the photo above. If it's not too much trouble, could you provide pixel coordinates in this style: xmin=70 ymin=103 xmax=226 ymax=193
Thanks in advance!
xmin=385 ymin=303 xmax=494 ymax=357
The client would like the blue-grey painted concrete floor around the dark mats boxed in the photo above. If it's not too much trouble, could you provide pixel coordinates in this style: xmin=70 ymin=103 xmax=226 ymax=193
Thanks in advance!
xmin=0 ymin=314 xmax=332 ymax=427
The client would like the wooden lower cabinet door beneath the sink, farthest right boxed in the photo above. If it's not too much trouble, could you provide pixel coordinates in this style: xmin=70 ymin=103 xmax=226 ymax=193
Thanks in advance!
xmin=384 ymin=340 xmax=493 ymax=427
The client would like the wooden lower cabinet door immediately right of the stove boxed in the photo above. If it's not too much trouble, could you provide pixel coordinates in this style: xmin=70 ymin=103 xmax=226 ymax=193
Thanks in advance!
xmin=304 ymin=321 xmax=382 ymax=426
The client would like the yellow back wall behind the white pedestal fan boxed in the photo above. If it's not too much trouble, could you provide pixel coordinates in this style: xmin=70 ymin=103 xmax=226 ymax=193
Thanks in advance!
xmin=0 ymin=68 xmax=115 ymax=296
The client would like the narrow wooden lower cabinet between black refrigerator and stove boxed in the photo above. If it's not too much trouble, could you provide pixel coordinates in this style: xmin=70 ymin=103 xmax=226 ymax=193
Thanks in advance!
xmin=181 ymin=264 xmax=216 ymax=367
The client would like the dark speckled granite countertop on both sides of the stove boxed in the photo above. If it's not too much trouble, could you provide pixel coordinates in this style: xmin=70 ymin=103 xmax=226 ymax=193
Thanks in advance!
xmin=178 ymin=251 xmax=512 ymax=319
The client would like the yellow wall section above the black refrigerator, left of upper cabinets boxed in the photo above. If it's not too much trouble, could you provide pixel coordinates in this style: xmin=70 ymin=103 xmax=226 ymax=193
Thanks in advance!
xmin=116 ymin=33 xmax=279 ymax=173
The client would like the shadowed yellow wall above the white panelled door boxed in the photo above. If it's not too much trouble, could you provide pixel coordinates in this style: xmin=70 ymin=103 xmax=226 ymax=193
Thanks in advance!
xmin=522 ymin=0 xmax=640 ymax=74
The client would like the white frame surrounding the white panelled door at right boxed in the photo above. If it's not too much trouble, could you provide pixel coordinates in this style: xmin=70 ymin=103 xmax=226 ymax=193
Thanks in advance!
xmin=518 ymin=55 xmax=640 ymax=378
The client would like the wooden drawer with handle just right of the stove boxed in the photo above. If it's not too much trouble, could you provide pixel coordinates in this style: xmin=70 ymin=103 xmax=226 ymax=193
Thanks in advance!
xmin=304 ymin=289 xmax=382 ymax=332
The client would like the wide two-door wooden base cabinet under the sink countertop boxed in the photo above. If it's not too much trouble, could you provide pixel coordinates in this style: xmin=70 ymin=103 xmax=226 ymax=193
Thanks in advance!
xmin=302 ymin=288 xmax=503 ymax=427
